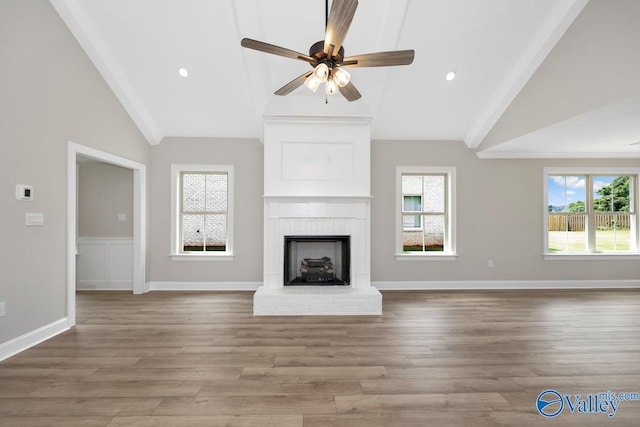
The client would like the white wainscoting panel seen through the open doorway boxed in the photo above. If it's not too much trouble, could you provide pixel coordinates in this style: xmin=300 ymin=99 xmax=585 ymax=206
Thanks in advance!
xmin=76 ymin=237 xmax=133 ymax=290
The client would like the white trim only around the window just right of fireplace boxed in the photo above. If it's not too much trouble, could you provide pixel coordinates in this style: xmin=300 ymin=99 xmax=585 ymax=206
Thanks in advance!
xmin=395 ymin=166 xmax=458 ymax=261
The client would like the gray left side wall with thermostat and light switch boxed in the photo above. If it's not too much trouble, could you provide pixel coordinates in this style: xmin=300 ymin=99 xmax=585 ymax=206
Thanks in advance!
xmin=0 ymin=0 xmax=149 ymax=343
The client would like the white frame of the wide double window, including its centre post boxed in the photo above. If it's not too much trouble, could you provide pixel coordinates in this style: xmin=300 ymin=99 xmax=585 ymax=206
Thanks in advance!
xmin=542 ymin=167 xmax=640 ymax=260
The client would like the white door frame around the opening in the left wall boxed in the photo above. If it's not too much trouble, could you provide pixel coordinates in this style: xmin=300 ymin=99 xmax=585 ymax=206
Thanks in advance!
xmin=67 ymin=141 xmax=148 ymax=327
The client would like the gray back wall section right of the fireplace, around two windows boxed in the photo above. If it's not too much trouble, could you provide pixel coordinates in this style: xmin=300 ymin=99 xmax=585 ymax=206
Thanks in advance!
xmin=371 ymin=141 xmax=640 ymax=282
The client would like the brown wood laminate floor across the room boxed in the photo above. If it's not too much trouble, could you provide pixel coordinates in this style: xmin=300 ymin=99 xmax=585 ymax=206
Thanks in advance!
xmin=0 ymin=290 xmax=640 ymax=427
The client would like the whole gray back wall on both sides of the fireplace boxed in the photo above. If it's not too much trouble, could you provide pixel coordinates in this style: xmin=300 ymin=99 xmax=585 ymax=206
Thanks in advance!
xmin=149 ymin=138 xmax=640 ymax=288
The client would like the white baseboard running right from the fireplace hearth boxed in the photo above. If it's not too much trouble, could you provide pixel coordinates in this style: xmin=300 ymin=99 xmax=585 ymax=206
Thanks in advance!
xmin=371 ymin=280 xmax=640 ymax=291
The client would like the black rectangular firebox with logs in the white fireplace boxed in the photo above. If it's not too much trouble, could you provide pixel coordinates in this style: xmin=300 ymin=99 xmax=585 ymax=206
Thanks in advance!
xmin=284 ymin=236 xmax=350 ymax=286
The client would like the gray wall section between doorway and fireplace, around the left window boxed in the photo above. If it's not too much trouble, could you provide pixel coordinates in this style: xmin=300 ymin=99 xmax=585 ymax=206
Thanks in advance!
xmin=147 ymin=138 xmax=263 ymax=282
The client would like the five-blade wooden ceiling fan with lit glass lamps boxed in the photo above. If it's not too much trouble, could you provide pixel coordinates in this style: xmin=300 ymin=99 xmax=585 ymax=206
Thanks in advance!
xmin=240 ymin=0 xmax=415 ymax=102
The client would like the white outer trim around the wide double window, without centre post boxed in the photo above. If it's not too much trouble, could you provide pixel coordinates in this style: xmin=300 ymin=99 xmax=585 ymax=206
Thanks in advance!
xmin=542 ymin=167 xmax=640 ymax=261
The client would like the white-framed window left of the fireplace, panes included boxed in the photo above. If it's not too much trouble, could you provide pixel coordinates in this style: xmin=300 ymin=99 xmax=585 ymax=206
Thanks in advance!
xmin=172 ymin=165 xmax=233 ymax=259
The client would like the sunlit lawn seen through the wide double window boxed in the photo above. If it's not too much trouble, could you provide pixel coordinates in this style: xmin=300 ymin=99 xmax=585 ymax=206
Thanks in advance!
xmin=549 ymin=230 xmax=631 ymax=252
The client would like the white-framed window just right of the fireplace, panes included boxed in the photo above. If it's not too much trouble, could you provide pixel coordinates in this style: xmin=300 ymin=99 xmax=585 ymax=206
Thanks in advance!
xmin=396 ymin=166 xmax=455 ymax=259
